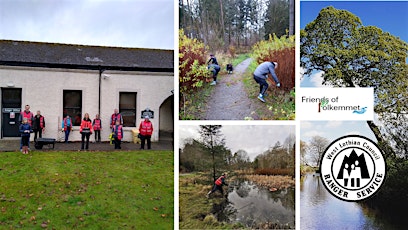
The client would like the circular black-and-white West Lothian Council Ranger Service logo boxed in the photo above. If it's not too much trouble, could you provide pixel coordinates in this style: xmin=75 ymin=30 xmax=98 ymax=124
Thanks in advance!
xmin=320 ymin=135 xmax=387 ymax=201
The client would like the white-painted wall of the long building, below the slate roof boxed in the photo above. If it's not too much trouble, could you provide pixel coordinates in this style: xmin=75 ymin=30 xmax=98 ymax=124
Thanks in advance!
xmin=0 ymin=66 xmax=174 ymax=141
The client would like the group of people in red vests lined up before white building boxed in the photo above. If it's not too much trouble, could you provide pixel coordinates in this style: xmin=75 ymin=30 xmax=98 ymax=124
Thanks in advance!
xmin=19 ymin=105 xmax=153 ymax=154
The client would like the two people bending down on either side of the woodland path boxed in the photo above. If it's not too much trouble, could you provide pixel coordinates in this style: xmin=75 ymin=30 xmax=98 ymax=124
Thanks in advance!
xmin=207 ymin=54 xmax=281 ymax=102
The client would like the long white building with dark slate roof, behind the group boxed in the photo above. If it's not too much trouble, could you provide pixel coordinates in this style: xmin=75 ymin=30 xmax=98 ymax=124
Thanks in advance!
xmin=0 ymin=40 xmax=174 ymax=141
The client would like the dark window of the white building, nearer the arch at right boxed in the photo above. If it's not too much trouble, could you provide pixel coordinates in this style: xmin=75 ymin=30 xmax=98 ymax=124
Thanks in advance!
xmin=119 ymin=92 xmax=137 ymax=127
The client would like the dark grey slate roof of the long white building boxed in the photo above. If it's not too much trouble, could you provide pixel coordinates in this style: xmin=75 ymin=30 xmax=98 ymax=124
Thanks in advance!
xmin=0 ymin=40 xmax=174 ymax=72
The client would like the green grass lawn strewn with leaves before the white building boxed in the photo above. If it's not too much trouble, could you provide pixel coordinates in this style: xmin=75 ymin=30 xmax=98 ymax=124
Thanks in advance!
xmin=0 ymin=151 xmax=174 ymax=229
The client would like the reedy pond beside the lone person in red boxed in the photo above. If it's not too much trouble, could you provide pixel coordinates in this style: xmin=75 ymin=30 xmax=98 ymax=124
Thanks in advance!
xmin=217 ymin=180 xmax=295 ymax=228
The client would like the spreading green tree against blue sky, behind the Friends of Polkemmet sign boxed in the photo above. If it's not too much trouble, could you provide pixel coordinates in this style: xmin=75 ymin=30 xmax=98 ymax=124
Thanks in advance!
xmin=300 ymin=7 xmax=408 ymax=160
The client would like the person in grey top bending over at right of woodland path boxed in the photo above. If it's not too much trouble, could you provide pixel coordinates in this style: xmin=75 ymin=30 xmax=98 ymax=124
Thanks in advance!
xmin=254 ymin=62 xmax=280 ymax=102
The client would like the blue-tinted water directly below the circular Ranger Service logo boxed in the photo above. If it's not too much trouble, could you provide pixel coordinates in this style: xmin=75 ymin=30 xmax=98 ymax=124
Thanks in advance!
xmin=300 ymin=173 xmax=393 ymax=229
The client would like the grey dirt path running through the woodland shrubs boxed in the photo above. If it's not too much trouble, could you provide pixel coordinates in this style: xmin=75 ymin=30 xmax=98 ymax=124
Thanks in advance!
xmin=205 ymin=58 xmax=259 ymax=120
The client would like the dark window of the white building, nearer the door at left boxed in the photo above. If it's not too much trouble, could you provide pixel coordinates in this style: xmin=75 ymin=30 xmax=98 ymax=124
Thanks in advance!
xmin=62 ymin=90 xmax=82 ymax=126
